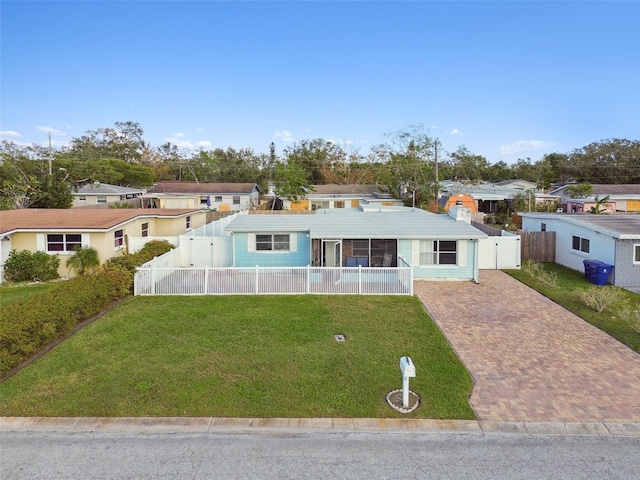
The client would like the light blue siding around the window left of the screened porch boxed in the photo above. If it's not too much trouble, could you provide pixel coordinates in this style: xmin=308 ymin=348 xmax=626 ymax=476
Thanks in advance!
xmin=233 ymin=232 xmax=311 ymax=267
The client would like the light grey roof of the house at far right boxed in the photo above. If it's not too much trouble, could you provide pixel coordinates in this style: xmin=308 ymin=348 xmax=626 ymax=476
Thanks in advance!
xmin=518 ymin=213 xmax=640 ymax=239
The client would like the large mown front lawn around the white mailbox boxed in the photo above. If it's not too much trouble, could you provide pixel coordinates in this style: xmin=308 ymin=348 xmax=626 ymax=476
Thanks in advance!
xmin=0 ymin=295 xmax=475 ymax=419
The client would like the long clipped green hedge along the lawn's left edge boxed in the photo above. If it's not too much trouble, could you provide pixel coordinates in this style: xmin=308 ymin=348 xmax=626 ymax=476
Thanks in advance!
xmin=0 ymin=241 xmax=173 ymax=377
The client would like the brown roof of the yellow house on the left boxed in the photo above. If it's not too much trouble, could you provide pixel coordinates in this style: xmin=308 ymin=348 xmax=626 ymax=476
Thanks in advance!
xmin=0 ymin=208 xmax=202 ymax=234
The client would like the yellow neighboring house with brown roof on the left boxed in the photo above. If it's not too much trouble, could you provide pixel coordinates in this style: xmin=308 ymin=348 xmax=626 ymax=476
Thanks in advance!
xmin=0 ymin=208 xmax=206 ymax=282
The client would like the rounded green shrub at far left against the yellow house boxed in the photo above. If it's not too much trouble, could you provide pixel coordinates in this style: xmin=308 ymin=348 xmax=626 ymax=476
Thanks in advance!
xmin=4 ymin=250 xmax=60 ymax=282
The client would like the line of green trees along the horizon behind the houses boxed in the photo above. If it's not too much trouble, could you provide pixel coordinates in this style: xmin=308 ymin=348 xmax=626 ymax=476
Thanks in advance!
xmin=0 ymin=122 xmax=640 ymax=209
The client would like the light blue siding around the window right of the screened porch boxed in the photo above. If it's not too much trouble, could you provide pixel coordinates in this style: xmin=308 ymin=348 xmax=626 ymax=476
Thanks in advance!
xmin=398 ymin=240 xmax=476 ymax=280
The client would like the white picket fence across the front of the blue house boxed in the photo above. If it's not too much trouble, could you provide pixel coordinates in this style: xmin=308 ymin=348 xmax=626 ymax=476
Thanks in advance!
xmin=134 ymin=262 xmax=413 ymax=295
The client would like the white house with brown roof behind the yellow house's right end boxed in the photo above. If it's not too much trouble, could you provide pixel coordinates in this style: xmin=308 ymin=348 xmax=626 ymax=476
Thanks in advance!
xmin=142 ymin=181 xmax=260 ymax=212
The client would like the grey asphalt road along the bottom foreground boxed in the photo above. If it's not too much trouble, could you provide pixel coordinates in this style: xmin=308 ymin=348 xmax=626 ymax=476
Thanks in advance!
xmin=0 ymin=432 xmax=640 ymax=480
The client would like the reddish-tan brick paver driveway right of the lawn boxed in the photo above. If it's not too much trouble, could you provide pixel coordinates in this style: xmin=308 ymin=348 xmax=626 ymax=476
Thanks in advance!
xmin=415 ymin=270 xmax=640 ymax=422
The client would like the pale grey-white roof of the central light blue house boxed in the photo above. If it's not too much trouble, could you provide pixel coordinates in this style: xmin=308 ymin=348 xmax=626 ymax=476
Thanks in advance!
xmin=225 ymin=207 xmax=487 ymax=239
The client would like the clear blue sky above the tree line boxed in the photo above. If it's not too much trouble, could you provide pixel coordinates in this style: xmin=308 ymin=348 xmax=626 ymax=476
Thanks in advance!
xmin=0 ymin=0 xmax=640 ymax=163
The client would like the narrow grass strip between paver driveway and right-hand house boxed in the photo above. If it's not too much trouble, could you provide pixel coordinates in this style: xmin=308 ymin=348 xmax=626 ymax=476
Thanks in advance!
xmin=505 ymin=263 xmax=640 ymax=353
